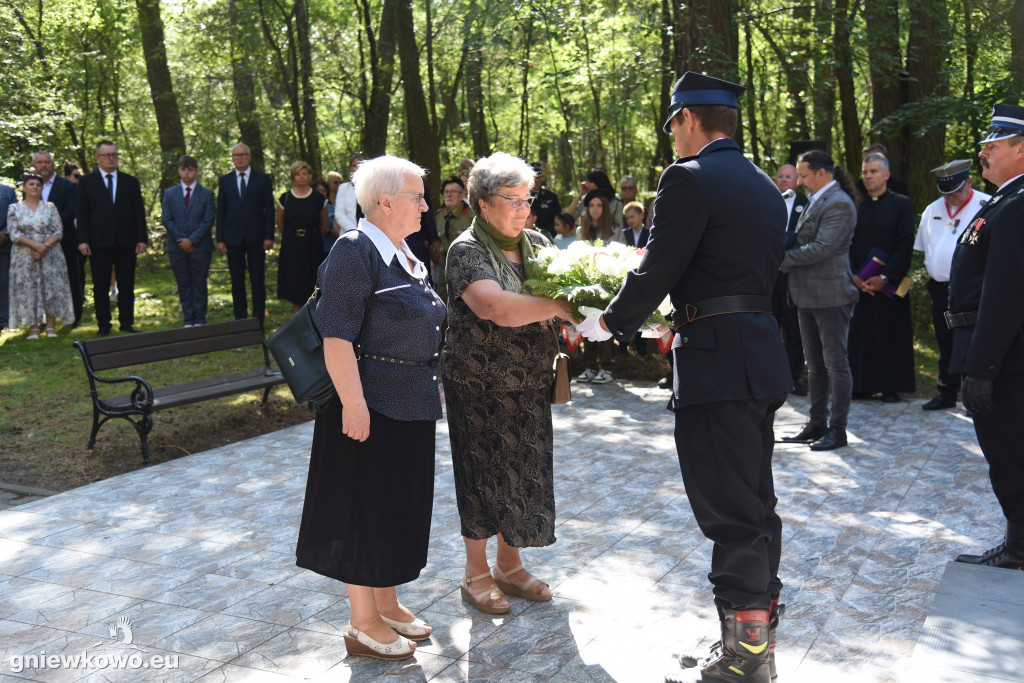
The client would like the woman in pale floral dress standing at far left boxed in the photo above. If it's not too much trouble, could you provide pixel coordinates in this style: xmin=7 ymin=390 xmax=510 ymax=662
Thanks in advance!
xmin=7 ymin=173 xmax=75 ymax=339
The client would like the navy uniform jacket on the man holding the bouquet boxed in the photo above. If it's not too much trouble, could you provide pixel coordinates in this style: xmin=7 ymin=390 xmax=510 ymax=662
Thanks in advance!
xmin=604 ymin=138 xmax=793 ymax=405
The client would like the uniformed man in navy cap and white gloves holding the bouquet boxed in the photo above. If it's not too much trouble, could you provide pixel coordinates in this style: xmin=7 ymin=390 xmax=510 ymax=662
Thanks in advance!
xmin=581 ymin=72 xmax=793 ymax=683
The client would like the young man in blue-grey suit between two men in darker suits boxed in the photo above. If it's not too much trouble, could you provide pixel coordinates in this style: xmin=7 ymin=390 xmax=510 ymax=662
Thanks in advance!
xmin=161 ymin=157 xmax=216 ymax=328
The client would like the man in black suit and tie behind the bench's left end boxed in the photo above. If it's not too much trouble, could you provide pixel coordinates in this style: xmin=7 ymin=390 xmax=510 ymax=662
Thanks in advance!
xmin=75 ymin=140 xmax=148 ymax=337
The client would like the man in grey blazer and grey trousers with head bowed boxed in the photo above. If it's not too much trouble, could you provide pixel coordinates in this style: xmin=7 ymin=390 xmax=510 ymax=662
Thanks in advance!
xmin=781 ymin=150 xmax=860 ymax=451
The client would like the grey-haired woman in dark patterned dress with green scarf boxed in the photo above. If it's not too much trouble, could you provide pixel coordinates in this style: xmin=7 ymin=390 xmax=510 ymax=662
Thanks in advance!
xmin=443 ymin=153 xmax=571 ymax=614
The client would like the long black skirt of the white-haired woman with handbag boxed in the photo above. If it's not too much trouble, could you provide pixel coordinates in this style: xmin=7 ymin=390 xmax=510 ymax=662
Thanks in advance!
xmin=295 ymin=400 xmax=436 ymax=588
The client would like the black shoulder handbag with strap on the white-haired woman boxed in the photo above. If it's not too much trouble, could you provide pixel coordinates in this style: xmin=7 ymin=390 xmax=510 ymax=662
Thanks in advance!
xmin=267 ymin=241 xmax=379 ymax=412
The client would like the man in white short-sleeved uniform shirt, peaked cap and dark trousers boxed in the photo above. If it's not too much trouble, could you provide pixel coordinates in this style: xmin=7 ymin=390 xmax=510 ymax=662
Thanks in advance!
xmin=913 ymin=159 xmax=989 ymax=411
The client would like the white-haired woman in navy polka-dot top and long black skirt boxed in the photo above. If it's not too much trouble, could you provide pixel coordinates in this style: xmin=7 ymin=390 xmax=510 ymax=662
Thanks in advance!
xmin=296 ymin=157 xmax=444 ymax=659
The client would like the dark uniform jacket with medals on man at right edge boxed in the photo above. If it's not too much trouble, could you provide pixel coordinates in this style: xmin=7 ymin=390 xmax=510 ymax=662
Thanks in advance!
xmin=949 ymin=176 xmax=1024 ymax=380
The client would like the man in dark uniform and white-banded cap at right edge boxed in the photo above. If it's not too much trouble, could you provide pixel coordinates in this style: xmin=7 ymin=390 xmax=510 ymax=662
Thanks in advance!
xmin=946 ymin=104 xmax=1024 ymax=569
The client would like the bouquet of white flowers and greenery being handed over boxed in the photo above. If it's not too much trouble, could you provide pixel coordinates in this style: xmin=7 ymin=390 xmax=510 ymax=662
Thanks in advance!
xmin=523 ymin=240 xmax=672 ymax=328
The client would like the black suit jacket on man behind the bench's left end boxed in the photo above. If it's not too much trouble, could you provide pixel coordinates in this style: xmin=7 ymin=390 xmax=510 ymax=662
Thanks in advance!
xmin=76 ymin=169 xmax=148 ymax=249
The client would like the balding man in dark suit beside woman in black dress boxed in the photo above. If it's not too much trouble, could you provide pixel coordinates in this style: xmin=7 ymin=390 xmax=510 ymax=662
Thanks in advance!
xmin=217 ymin=143 xmax=274 ymax=325
